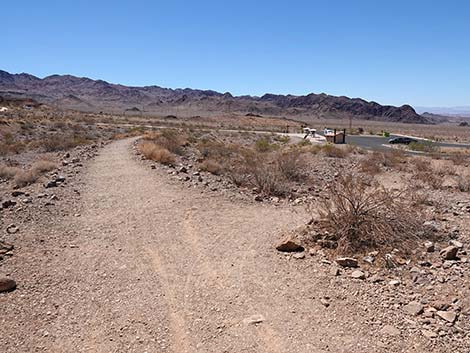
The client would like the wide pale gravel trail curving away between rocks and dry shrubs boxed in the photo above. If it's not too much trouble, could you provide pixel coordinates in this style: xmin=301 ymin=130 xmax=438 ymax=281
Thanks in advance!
xmin=2 ymin=140 xmax=440 ymax=353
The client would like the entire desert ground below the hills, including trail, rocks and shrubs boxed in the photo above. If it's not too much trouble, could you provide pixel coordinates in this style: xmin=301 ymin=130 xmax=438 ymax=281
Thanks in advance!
xmin=0 ymin=103 xmax=470 ymax=353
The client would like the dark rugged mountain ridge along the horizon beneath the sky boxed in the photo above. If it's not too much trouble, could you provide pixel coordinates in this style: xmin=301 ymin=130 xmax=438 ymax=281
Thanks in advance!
xmin=0 ymin=70 xmax=432 ymax=124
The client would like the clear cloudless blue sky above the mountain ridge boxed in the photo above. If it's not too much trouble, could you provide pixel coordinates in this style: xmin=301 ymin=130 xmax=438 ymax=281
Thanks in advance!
xmin=0 ymin=0 xmax=470 ymax=106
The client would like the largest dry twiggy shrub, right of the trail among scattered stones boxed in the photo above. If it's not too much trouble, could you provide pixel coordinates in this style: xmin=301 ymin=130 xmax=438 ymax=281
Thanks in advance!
xmin=319 ymin=174 xmax=422 ymax=253
